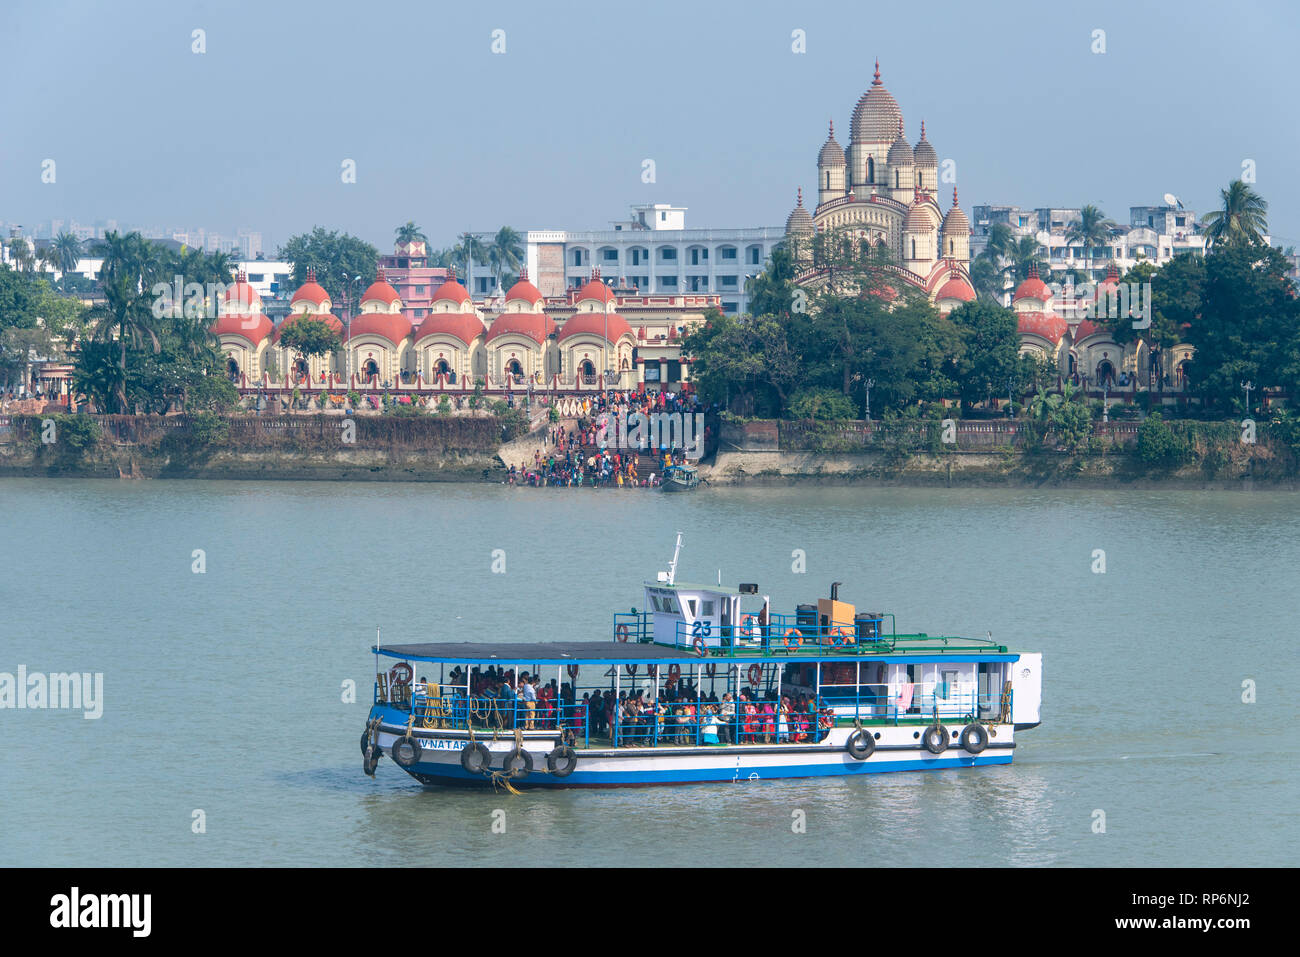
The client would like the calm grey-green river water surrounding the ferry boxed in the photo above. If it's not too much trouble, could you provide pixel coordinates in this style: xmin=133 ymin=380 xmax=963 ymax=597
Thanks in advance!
xmin=0 ymin=479 xmax=1300 ymax=866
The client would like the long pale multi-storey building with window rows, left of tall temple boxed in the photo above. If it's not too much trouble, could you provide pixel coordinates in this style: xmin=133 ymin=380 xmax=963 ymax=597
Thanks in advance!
xmin=527 ymin=203 xmax=785 ymax=312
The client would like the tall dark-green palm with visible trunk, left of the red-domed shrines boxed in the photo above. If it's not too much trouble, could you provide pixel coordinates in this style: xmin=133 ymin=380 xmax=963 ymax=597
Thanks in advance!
xmin=86 ymin=231 xmax=163 ymax=412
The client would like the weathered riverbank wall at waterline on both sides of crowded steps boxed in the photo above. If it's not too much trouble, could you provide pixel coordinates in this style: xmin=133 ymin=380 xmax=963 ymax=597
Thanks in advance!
xmin=0 ymin=415 xmax=1300 ymax=489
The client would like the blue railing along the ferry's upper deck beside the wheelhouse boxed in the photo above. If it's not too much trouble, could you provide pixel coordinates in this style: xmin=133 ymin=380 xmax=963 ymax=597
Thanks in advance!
xmin=673 ymin=614 xmax=898 ymax=657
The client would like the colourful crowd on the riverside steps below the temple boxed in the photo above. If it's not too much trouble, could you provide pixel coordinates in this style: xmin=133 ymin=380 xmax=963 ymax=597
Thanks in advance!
xmin=506 ymin=391 xmax=711 ymax=489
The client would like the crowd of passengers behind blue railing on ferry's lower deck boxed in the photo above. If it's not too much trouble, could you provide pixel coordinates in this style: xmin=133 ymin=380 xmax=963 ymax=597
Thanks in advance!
xmin=415 ymin=666 xmax=835 ymax=748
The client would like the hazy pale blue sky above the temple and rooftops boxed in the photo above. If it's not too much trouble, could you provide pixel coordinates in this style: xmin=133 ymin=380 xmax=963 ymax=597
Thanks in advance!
xmin=0 ymin=0 xmax=1300 ymax=251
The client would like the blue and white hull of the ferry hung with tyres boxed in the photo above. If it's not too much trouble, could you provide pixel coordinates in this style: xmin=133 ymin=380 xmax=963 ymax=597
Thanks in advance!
xmin=366 ymin=724 xmax=1015 ymax=788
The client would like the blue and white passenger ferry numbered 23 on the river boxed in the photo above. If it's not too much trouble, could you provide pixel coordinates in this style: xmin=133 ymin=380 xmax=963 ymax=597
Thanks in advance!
xmin=361 ymin=533 xmax=1043 ymax=789
